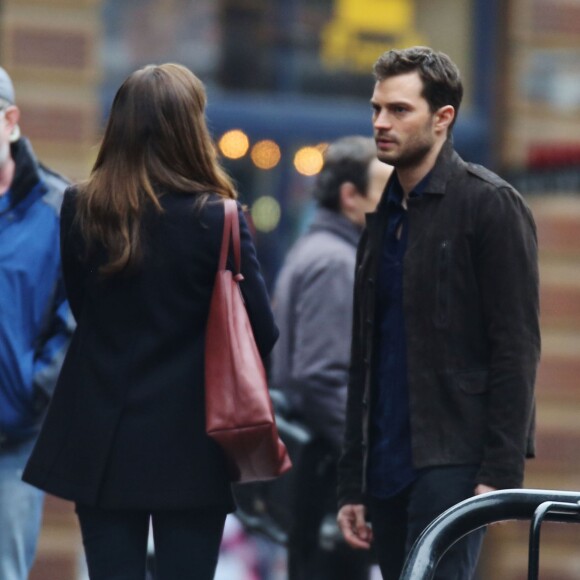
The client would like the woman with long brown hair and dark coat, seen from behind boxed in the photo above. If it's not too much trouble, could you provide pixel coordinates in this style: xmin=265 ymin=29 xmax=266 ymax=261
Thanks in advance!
xmin=24 ymin=64 xmax=278 ymax=580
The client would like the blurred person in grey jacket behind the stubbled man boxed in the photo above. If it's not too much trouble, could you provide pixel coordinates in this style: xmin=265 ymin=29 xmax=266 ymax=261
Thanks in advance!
xmin=270 ymin=136 xmax=392 ymax=580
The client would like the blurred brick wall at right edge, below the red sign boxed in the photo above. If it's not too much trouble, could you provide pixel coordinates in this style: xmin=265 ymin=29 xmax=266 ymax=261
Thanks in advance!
xmin=481 ymin=196 xmax=580 ymax=580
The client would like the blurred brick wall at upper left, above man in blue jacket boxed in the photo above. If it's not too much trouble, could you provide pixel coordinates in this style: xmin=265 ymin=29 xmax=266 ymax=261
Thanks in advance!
xmin=0 ymin=0 xmax=100 ymax=180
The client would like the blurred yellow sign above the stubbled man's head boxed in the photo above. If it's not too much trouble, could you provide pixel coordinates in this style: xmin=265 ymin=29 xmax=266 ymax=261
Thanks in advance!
xmin=321 ymin=0 xmax=423 ymax=72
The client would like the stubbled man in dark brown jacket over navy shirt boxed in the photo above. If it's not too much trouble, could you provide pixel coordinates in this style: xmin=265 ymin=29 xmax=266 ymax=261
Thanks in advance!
xmin=339 ymin=47 xmax=540 ymax=580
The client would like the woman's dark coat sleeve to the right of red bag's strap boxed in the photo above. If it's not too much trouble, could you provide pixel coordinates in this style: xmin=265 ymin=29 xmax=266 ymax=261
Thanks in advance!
xmin=238 ymin=204 xmax=278 ymax=358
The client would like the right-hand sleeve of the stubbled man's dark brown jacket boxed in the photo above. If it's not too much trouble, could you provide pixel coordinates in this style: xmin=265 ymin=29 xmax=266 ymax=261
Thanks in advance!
xmin=476 ymin=187 xmax=540 ymax=488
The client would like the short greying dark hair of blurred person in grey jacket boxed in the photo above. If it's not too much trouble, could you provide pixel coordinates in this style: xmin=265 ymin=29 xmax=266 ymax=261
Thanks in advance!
xmin=313 ymin=136 xmax=377 ymax=211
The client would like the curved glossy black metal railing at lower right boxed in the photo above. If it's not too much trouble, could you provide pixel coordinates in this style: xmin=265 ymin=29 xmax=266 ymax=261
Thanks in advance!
xmin=400 ymin=489 xmax=580 ymax=580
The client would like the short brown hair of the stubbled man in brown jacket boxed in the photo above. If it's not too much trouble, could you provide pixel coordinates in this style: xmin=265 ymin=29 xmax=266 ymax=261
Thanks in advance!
xmin=373 ymin=46 xmax=463 ymax=128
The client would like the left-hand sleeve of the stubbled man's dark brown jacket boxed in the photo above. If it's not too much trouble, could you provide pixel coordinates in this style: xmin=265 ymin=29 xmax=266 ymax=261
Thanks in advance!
xmin=337 ymin=230 xmax=368 ymax=507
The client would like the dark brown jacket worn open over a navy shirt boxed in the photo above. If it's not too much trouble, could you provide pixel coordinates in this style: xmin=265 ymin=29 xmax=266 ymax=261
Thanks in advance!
xmin=338 ymin=140 xmax=540 ymax=505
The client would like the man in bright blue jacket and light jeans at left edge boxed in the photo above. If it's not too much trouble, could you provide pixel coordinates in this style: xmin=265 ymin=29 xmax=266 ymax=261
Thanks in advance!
xmin=0 ymin=67 xmax=74 ymax=580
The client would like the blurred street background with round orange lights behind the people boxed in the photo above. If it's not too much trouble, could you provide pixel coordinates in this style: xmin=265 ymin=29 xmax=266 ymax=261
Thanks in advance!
xmin=0 ymin=0 xmax=580 ymax=580
